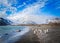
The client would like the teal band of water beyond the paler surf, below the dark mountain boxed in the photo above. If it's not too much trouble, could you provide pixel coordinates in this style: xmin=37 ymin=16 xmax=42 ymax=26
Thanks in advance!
xmin=0 ymin=26 xmax=25 ymax=34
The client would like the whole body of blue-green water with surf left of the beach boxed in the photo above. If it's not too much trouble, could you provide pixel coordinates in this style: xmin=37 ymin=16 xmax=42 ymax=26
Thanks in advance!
xmin=0 ymin=26 xmax=29 ymax=43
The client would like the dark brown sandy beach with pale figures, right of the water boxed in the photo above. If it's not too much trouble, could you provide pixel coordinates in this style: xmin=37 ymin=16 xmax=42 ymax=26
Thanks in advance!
xmin=15 ymin=24 xmax=60 ymax=43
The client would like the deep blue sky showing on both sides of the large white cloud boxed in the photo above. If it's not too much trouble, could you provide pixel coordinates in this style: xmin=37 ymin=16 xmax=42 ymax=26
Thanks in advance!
xmin=0 ymin=0 xmax=60 ymax=17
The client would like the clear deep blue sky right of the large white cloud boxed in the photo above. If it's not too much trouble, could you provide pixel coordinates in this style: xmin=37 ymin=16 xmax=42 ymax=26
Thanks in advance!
xmin=42 ymin=0 xmax=60 ymax=16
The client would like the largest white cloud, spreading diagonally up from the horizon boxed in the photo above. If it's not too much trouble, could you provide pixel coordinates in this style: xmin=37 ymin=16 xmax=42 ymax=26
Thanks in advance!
xmin=7 ymin=1 xmax=53 ymax=24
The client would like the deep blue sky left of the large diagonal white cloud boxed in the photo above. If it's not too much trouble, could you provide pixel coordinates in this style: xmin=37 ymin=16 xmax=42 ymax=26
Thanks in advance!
xmin=6 ymin=0 xmax=37 ymax=15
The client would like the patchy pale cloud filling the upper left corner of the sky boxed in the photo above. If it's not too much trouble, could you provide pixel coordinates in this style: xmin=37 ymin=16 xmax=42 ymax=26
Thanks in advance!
xmin=0 ymin=0 xmax=17 ymax=17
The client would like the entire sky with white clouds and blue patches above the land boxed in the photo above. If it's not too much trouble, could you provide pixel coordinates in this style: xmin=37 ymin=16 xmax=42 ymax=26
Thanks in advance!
xmin=0 ymin=0 xmax=60 ymax=24
